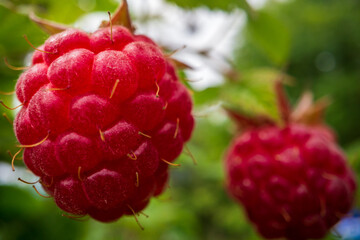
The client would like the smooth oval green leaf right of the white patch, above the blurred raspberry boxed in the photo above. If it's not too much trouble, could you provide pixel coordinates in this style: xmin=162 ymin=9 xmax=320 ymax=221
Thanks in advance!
xmin=246 ymin=12 xmax=290 ymax=67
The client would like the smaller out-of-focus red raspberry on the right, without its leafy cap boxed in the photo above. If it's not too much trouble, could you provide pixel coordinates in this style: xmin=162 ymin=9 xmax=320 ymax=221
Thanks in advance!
xmin=225 ymin=86 xmax=356 ymax=239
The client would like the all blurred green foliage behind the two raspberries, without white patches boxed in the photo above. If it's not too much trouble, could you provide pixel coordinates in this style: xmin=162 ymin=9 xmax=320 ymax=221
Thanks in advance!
xmin=0 ymin=0 xmax=360 ymax=240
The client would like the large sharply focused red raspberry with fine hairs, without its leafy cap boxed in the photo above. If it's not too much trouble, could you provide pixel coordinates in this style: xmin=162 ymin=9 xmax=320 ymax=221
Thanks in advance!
xmin=14 ymin=26 xmax=194 ymax=222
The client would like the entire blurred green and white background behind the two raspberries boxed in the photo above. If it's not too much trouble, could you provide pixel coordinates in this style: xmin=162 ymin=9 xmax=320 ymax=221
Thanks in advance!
xmin=0 ymin=0 xmax=360 ymax=240
